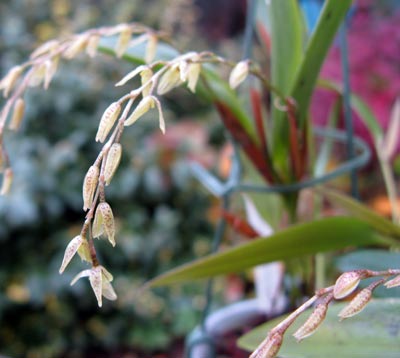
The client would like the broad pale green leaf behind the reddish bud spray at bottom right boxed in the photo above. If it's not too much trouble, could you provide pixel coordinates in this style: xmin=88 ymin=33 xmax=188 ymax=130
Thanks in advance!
xmin=238 ymin=299 xmax=400 ymax=358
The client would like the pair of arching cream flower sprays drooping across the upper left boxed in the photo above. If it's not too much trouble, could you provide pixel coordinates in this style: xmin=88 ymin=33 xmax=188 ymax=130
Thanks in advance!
xmin=0 ymin=23 xmax=250 ymax=306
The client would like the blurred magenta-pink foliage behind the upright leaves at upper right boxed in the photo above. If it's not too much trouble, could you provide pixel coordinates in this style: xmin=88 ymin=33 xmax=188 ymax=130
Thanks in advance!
xmin=311 ymin=1 xmax=400 ymax=154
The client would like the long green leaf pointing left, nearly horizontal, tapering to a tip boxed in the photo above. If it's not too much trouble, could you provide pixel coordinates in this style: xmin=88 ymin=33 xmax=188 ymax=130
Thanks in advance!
xmin=148 ymin=217 xmax=388 ymax=286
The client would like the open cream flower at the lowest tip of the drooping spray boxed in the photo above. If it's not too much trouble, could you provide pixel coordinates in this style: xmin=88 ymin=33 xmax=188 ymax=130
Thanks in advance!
xmin=71 ymin=266 xmax=117 ymax=307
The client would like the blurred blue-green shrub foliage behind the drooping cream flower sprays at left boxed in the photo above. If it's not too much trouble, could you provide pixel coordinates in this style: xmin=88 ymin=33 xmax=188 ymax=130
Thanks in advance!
xmin=0 ymin=0 xmax=228 ymax=357
